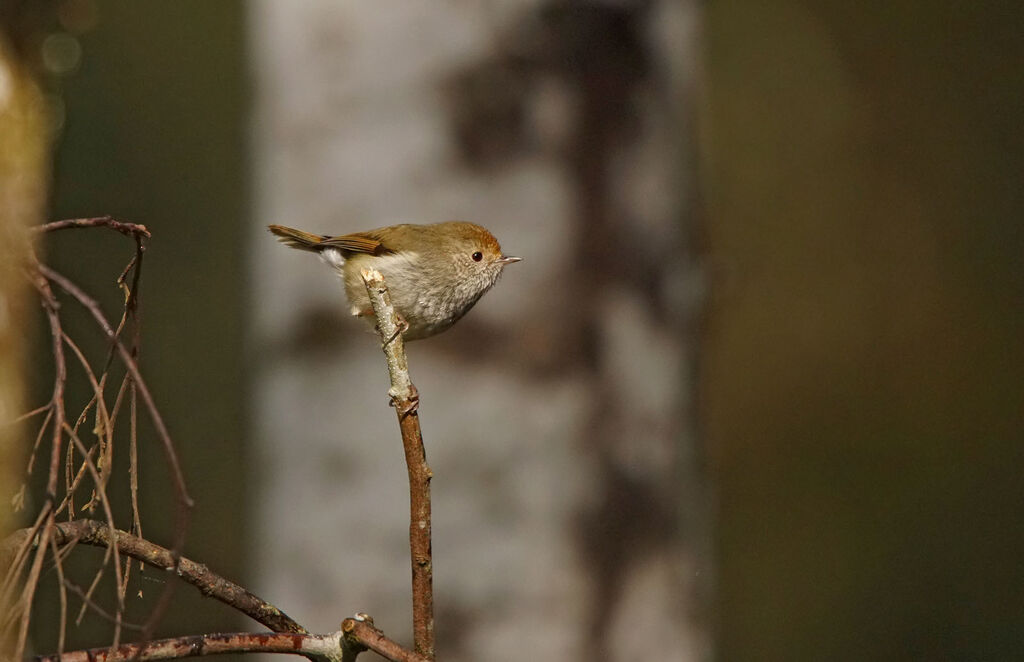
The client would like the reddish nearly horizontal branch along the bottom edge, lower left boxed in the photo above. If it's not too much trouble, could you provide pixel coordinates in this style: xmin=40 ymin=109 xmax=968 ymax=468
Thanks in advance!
xmin=36 ymin=632 xmax=351 ymax=662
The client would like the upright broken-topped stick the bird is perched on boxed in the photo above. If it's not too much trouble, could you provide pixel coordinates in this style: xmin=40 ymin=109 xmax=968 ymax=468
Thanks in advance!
xmin=361 ymin=270 xmax=434 ymax=660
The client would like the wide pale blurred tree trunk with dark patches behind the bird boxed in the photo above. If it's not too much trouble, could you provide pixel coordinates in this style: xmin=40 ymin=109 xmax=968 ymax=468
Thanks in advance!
xmin=251 ymin=0 xmax=713 ymax=661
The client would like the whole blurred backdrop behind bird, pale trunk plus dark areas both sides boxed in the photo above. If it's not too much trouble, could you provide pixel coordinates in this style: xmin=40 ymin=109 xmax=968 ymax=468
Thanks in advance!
xmin=8 ymin=0 xmax=1024 ymax=661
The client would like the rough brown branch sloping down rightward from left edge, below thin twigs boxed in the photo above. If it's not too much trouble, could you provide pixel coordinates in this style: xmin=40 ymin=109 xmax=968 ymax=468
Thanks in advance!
xmin=0 ymin=520 xmax=307 ymax=633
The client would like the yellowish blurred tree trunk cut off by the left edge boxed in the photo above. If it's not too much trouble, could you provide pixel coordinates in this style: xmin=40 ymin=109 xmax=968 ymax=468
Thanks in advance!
xmin=0 ymin=29 xmax=47 ymax=651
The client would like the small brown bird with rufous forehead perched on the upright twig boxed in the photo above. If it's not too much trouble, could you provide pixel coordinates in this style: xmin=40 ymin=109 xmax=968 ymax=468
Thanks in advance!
xmin=269 ymin=221 xmax=522 ymax=340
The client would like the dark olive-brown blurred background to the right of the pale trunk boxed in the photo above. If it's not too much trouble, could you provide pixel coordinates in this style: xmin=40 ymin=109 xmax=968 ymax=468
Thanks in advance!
xmin=703 ymin=1 xmax=1024 ymax=660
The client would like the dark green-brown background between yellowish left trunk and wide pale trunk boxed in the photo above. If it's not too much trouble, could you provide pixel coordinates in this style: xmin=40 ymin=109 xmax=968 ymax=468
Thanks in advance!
xmin=39 ymin=0 xmax=249 ymax=650
